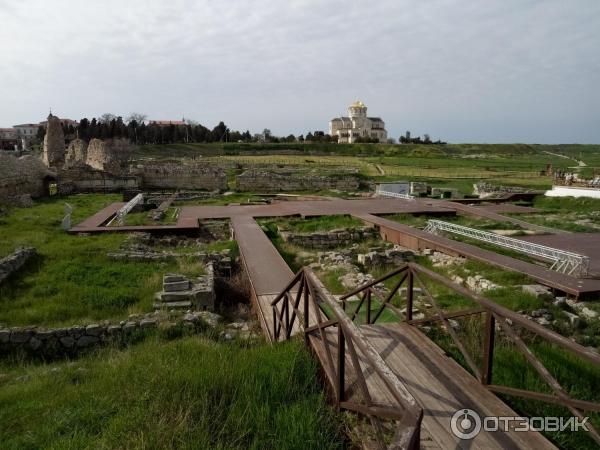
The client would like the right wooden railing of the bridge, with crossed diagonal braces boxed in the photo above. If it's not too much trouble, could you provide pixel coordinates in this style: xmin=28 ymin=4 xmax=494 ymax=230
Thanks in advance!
xmin=340 ymin=263 xmax=600 ymax=444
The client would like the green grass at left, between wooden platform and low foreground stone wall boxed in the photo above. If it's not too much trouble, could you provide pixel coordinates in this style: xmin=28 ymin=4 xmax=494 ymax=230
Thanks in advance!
xmin=0 ymin=195 xmax=234 ymax=326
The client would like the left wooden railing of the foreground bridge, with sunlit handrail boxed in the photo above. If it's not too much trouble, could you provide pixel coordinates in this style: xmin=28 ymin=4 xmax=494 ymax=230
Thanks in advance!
xmin=271 ymin=268 xmax=423 ymax=449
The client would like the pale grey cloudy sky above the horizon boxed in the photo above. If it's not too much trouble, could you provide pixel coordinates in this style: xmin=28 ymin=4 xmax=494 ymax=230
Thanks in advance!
xmin=0 ymin=0 xmax=600 ymax=143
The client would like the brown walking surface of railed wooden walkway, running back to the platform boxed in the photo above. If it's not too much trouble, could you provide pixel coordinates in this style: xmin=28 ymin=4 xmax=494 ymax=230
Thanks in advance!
xmin=226 ymin=216 xmax=554 ymax=450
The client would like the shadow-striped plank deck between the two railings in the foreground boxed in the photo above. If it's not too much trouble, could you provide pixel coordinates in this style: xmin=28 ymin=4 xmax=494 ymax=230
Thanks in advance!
xmin=361 ymin=323 xmax=554 ymax=449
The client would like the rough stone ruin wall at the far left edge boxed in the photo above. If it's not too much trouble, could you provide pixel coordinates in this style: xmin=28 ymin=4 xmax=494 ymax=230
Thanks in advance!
xmin=0 ymin=152 xmax=56 ymax=203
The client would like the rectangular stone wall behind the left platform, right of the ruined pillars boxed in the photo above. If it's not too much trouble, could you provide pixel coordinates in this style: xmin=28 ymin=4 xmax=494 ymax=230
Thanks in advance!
xmin=135 ymin=164 xmax=227 ymax=190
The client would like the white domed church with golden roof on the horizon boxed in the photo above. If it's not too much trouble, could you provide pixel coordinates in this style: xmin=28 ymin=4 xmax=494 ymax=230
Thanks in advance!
xmin=329 ymin=101 xmax=387 ymax=144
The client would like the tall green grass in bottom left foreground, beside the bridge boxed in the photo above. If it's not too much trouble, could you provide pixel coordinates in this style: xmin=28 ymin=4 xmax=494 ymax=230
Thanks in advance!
xmin=0 ymin=337 xmax=344 ymax=450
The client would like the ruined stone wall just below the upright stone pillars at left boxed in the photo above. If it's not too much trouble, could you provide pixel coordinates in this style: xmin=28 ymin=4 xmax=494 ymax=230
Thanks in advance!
xmin=57 ymin=165 xmax=140 ymax=195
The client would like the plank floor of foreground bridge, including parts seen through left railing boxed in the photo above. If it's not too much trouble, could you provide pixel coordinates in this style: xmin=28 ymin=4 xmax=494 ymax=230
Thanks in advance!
xmin=309 ymin=323 xmax=555 ymax=450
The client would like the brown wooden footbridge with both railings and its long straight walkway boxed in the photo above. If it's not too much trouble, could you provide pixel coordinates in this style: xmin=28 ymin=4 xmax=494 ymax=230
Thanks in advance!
xmin=232 ymin=217 xmax=600 ymax=450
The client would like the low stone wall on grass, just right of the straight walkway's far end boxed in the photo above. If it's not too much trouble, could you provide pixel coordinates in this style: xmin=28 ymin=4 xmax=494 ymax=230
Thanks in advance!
xmin=279 ymin=227 xmax=379 ymax=249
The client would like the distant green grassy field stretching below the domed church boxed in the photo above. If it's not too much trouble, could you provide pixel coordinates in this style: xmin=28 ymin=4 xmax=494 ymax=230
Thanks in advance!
xmin=134 ymin=143 xmax=600 ymax=194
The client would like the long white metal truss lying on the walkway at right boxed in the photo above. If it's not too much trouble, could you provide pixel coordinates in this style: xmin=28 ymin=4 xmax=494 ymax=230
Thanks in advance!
xmin=425 ymin=220 xmax=590 ymax=277
